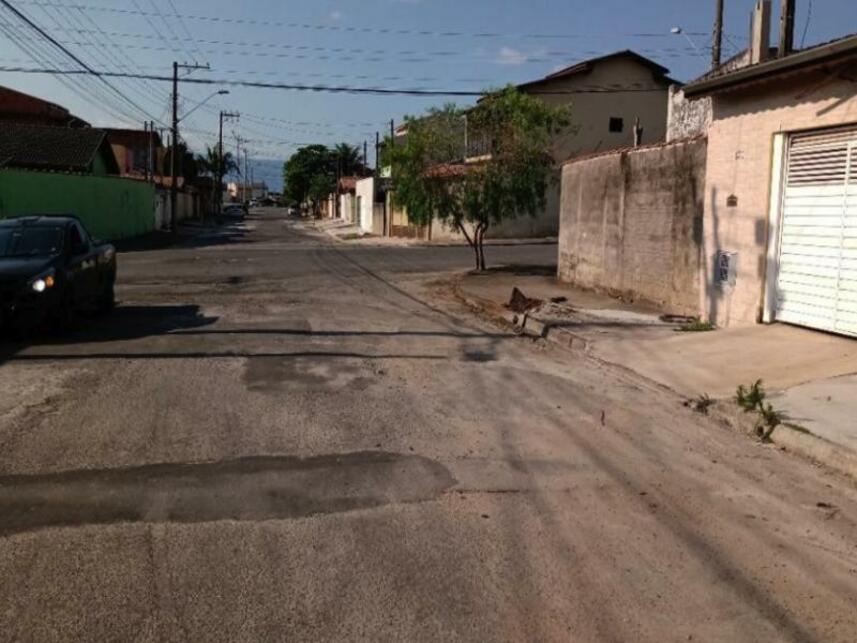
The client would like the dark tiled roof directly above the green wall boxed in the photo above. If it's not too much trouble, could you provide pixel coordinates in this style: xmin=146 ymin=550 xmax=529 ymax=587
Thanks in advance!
xmin=0 ymin=122 xmax=118 ymax=173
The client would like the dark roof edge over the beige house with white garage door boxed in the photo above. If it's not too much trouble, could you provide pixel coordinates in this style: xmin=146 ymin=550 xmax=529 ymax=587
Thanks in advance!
xmin=684 ymin=34 xmax=857 ymax=98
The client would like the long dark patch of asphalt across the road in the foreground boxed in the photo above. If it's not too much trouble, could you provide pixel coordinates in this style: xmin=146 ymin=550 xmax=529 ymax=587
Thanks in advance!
xmin=0 ymin=452 xmax=455 ymax=536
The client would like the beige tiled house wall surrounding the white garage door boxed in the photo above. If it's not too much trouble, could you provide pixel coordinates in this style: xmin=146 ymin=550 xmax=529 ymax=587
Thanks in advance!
xmin=700 ymin=75 xmax=857 ymax=326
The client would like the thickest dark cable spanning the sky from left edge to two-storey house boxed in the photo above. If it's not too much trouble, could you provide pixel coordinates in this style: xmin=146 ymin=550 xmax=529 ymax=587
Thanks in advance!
xmin=0 ymin=65 xmax=666 ymax=98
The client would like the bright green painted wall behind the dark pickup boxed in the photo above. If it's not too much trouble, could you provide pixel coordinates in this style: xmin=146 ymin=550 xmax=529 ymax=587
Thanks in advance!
xmin=0 ymin=169 xmax=155 ymax=241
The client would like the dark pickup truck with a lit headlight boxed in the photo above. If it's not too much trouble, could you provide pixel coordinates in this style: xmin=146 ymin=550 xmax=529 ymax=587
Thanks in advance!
xmin=0 ymin=216 xmax=116 ymax=331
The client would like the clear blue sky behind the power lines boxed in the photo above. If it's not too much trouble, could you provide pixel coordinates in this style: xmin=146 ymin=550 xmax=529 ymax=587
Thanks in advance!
xmin=0 ymin=0 xmax=857 ymax=189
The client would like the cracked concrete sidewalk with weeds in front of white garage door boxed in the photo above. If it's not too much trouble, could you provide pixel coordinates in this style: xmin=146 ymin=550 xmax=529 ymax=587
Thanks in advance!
xmin=457 ymin=270 xmax=857 ymax=477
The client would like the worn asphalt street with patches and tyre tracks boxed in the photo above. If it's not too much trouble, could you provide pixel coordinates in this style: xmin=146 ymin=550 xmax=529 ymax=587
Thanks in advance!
xmin=0 ymin=211 xmax=857 ymax=642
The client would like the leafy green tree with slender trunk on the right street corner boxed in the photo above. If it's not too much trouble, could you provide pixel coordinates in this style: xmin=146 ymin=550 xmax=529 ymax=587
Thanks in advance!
xmin=385 ymin=87 xmax=570 ymax=270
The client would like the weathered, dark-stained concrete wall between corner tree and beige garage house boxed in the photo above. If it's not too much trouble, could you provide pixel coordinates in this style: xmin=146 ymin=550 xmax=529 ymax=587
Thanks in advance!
xmin=559 ymin=139 xmax=706 ymax=315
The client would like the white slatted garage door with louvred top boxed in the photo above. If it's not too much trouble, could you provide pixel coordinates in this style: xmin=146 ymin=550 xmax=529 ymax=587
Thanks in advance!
xmin=776 ymin=128 xmax=857 ymax=336
